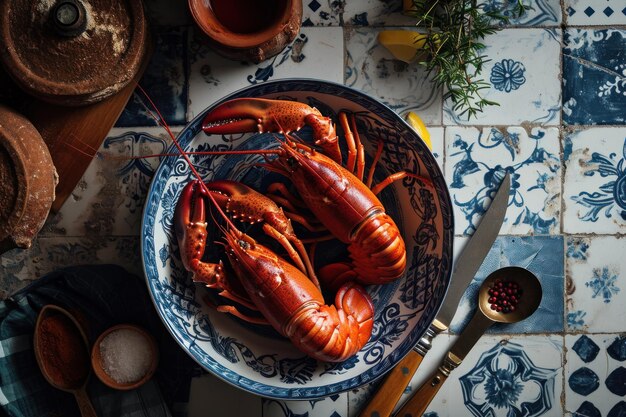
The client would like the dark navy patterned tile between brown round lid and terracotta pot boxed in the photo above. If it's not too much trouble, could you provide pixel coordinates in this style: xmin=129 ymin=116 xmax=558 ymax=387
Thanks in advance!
xmin=115 ymin=26 xmax=189 ymax=127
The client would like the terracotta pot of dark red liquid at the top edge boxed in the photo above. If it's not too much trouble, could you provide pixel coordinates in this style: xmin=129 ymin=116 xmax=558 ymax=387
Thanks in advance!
xmin=189 ymin=0 xmax=302 ymax=63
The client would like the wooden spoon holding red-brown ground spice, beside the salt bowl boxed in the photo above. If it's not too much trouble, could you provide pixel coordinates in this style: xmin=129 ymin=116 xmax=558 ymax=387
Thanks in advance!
xmin=33 ymin=304 xmax=97 ymax=417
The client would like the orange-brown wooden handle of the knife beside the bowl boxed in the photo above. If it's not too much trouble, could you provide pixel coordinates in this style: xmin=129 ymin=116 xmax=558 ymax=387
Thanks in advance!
xmin=359 ymin=350 xmax=424 ymax=417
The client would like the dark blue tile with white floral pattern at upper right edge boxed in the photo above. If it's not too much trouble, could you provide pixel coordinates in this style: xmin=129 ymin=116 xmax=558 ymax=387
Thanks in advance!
xmin=563 ymin=28 xmax=626 ymax=125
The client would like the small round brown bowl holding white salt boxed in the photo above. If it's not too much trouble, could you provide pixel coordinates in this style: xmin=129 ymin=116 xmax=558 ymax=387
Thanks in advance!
xmin=91 ymin=324 xmax=159 ymax=390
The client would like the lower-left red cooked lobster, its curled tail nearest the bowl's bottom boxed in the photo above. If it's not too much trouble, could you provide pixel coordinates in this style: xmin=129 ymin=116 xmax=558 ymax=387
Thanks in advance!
xmin=175 ymin=180 xmax=374 ymax=362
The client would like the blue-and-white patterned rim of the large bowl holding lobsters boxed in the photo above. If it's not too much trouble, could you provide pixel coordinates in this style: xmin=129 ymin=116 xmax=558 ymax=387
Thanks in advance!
xmin=140 ymin=77 xmax=454 ymax=400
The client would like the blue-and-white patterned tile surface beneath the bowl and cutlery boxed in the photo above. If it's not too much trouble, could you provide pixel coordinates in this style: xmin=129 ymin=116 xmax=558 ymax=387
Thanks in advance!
xmin=0 ymin=0 xmax=626 ymax=417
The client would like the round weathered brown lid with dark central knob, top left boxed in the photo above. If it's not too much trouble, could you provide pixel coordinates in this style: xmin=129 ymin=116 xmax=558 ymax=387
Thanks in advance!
xmin=0 ymin=0 xmax=148 ymax=106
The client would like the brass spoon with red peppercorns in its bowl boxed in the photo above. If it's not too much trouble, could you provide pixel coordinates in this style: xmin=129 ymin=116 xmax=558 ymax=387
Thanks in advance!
xmin=396 ymin=266 xmax=542 ymax=417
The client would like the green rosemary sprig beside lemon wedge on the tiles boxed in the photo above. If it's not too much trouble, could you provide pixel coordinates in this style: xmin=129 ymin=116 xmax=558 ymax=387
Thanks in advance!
xmin=409 ymin=0 xmax=530 ymax=120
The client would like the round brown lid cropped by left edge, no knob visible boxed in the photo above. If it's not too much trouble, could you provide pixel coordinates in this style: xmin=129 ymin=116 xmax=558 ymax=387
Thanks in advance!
xmin=0 ymin=105 xmax=58 ymax=253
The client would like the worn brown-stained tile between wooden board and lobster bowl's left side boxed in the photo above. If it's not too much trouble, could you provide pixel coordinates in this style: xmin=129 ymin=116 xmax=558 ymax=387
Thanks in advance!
xmin=41 ymin=127 xmax=171 ymax=236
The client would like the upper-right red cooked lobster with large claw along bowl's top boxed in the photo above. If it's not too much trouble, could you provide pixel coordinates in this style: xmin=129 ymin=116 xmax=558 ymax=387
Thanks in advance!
xmin=203 ymin=98 xmax=422 ymax=288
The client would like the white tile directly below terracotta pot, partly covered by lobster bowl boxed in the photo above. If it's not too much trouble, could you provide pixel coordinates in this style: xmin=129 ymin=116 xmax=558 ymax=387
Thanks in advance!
xmin=189 ymin=27 xmax=343 ymax=118
